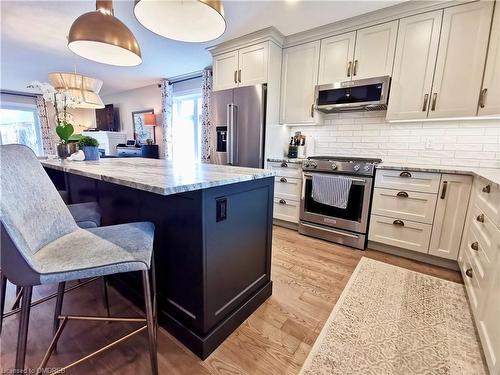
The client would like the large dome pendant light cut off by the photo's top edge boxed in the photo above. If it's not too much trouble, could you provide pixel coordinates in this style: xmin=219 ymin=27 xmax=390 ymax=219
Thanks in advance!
xmin=134 ymin=0 xmax=226 ymax=42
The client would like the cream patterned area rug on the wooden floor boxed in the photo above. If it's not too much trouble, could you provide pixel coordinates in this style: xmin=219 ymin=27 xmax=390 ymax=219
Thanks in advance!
xmin=301 ymin=257 xmax=488 ymax=375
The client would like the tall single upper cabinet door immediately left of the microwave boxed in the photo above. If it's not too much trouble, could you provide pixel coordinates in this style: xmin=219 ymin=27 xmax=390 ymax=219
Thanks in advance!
xmin=281 ymin=40 xmax=320 ymax=124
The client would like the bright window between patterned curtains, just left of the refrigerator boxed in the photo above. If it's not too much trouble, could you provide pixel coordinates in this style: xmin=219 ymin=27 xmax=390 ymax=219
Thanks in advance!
xmin=172 ymin=93 xmax=201 ymax=162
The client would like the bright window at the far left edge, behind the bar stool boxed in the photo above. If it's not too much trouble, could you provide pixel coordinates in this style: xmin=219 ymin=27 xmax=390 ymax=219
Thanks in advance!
xmin=0 ymin=103 xmax=43 ymax=156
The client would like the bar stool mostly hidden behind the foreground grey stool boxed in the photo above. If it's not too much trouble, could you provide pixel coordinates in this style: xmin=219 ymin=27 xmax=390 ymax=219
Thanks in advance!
xmin=0 ymin=200 xmax=106 ymax=334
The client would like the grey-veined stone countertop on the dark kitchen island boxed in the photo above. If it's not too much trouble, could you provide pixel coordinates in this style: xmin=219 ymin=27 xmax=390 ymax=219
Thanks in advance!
xmin=41 ymin=158 xmax=274 ymax=195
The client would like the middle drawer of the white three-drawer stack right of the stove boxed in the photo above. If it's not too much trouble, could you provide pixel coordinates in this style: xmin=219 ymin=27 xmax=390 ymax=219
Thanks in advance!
xmin=372 ymin=188 xmax=437 ymax=224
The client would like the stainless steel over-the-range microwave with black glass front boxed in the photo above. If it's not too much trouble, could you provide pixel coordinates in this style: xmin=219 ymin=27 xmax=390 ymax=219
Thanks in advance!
xmin=315 ymin=76 xmax=391 ymax=113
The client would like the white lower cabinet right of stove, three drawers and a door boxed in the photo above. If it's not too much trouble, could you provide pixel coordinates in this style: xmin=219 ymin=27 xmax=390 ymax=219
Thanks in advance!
xmin=368 ymin=170 xmax=472 ymax=260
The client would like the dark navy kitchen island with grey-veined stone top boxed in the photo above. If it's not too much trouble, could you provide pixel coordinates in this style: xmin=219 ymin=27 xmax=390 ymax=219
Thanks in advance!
xmin=42 ymin=158 xmax=274 ymax=359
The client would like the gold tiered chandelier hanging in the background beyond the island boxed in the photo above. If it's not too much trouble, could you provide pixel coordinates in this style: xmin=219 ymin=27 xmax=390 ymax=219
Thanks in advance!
xmin=49 ymin=72 xmax=104 ymax=109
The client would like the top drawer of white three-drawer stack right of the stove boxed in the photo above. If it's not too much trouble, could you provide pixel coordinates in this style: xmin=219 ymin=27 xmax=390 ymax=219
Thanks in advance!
xmin=375 ymin=169 xmax=441 ymax=193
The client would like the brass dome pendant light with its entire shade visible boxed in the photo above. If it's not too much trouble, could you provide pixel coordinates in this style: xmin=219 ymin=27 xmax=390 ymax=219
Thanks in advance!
xmin=68 ymin=0 xmax=142 ymax=66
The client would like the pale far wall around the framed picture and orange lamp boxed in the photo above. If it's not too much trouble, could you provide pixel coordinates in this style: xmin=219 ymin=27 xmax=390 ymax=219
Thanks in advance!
xmin=101 ymin=83 xmax=164 ymax=156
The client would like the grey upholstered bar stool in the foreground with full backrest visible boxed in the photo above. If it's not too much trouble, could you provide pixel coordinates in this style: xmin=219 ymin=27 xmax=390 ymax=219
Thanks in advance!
xmin=0 ymin=145 xmax=158 ymax=374
